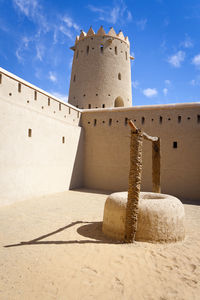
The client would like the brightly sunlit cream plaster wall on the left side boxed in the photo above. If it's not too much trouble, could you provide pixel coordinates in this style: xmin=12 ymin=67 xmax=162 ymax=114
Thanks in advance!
xmin=0 ymin=69 xmax=83 ymax=205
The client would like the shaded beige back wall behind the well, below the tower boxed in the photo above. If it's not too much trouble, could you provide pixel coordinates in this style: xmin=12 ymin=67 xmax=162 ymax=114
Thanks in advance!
xmin=82 ymin=103 xmax=200 ymax=200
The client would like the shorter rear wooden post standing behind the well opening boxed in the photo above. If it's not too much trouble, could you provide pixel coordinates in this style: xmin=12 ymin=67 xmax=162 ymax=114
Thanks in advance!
xmin=152 ymin=138 xmax=161 ymax=193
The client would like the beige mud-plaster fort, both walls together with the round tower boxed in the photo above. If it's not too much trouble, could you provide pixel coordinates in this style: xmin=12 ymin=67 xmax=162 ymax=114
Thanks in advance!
xmin=0 ymin=27 xmax=200 ymax=205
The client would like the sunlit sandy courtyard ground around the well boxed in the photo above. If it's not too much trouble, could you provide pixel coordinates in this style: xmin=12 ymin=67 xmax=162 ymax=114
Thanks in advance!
xmin=0 ymin=191 xmax=200 ymax=300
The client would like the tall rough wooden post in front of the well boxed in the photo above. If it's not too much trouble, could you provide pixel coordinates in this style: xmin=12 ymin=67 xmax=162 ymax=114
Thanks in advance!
xmin=124 ymin=125 xmax=143 ymax=243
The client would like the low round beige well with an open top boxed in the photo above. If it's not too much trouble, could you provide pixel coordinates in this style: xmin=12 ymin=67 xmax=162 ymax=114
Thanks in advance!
xmin=103 ymin=192 xmax=185 ymax=243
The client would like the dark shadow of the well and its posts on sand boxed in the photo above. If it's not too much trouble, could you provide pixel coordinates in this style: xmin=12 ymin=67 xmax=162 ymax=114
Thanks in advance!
xmin=4 ymin=221 xmax=122 ymax=248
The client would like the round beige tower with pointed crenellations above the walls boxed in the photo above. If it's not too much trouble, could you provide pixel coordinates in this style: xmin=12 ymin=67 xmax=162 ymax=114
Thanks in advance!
xmin=68 ymin=26 xmax=132 ymax=109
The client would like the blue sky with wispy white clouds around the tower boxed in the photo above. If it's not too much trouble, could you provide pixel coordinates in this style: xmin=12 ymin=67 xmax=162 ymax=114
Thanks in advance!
xmin=0 ymin=0 xmax=200 ymax=105
